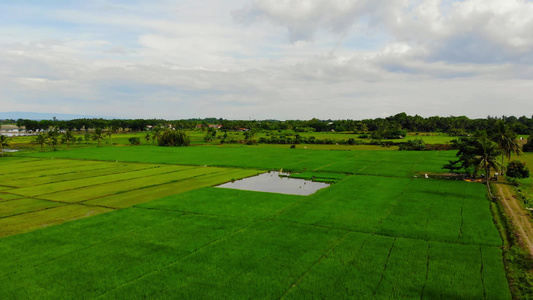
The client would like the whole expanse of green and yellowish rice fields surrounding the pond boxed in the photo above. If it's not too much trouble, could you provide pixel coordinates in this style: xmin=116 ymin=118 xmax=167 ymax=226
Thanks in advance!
xmin=0 ymin=147 xmax=511 ymax=299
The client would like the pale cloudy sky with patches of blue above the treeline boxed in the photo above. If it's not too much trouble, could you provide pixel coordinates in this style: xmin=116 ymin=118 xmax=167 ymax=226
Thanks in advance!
xmin=0 ymin=0 xmax=533 ymax=120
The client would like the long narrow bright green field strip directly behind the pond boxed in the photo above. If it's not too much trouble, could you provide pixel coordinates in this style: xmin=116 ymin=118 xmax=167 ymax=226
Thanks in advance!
xmin=23 ymin=146 xmax=455 ymax=177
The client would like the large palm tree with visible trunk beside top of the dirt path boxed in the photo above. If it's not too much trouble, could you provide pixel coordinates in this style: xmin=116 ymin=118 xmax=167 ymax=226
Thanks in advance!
xmin=472 ymin=137 xmax=503 ymax=198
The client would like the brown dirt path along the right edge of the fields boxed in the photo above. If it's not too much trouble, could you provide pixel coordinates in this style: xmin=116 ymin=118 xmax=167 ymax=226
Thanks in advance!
xmin=495 ymin=182 xmax=533 ymax=256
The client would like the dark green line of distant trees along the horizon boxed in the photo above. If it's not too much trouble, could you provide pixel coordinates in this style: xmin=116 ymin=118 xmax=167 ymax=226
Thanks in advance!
xmin=12 ymin=113 xmax=533 ymax=136
